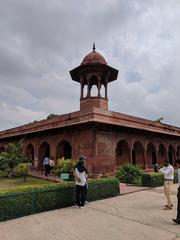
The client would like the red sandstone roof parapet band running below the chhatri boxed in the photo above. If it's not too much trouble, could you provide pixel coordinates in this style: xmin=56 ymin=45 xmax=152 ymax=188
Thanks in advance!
xmin=0 ymin=107 xmax=180 ymax=139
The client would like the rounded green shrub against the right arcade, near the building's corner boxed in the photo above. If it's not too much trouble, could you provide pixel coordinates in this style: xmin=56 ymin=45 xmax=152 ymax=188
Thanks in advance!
xmin=115 ymin=163 xmax=142 ymax=183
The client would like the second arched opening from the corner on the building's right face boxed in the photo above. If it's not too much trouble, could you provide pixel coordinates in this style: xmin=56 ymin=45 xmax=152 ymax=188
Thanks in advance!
xmin=132 ymin=141 xmax=144 ymax=168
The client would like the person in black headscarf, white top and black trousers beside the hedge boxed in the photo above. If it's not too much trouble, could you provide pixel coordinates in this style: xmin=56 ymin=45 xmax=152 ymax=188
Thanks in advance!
xmin=74 ymin=157 xmax=87 ymax=208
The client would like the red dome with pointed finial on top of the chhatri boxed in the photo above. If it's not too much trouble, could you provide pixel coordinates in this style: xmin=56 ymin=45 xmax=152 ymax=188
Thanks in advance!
xmin=81 ymin=43 xmax=107 ymax=65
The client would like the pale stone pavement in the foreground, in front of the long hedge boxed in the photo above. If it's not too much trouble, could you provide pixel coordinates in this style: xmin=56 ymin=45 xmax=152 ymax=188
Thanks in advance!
xmin=0 ymin=184 xmax=180 ymax=240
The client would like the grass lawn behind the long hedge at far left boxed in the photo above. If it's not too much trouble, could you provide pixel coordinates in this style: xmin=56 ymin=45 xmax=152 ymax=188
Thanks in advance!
xmin=0 ymin=171 xmax=52 ymax=189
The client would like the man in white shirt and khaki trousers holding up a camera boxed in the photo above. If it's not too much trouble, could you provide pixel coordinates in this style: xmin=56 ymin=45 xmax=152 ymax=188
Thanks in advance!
xmin=159 ymin=160 xmax=174 ymax=210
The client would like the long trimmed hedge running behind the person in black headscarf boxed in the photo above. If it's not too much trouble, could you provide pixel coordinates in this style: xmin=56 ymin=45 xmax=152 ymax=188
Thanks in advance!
xmin=0 ymin=178 xmax=119 ymax=221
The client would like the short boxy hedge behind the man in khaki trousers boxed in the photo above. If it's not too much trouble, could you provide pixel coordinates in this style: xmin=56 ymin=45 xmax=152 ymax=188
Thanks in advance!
xmin=141 ymin=169 xmax=178 ymax=187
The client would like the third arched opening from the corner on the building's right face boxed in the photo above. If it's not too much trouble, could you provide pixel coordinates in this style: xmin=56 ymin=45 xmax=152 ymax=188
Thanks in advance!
xmin=146 ymin=143 xmax=157 ymax=168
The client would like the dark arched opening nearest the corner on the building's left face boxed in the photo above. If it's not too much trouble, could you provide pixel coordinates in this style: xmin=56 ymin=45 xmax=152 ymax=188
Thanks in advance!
xmin=56 ymin=140 xmax=72 ymax=159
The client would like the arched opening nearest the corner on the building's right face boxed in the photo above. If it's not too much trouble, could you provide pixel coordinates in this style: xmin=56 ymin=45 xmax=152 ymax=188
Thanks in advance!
xmin=116 ymin=140 xmax=130 ymax=167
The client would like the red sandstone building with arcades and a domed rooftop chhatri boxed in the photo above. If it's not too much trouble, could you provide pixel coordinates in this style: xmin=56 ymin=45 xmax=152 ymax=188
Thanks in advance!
xmin=0 ymin=46 xmax=180 ymax=173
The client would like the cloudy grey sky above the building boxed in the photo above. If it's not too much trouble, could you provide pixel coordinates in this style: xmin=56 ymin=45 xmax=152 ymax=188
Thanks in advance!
xmin=0 ymin=0 xmax=180 ymax=130
